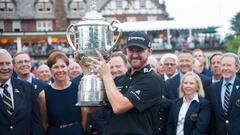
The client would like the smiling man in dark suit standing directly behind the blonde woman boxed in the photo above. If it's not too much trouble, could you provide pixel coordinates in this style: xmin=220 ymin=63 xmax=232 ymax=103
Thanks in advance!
xmin=165 ymin=51 xmax=212 ymax=99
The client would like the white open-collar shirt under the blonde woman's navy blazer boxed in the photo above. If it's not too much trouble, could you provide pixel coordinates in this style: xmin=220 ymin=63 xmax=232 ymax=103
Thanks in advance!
xmin=177 ymin=93 xmax=199 ymax=135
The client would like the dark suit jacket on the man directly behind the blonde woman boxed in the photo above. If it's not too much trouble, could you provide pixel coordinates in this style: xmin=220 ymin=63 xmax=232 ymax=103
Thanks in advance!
xmin=165 ymin=73 xmax=212 ymax=99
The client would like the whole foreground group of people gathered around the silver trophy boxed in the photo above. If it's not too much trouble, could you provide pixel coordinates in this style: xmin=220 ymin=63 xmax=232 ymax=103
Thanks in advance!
xmin=0 ymin=32 xmax=240 ymax=135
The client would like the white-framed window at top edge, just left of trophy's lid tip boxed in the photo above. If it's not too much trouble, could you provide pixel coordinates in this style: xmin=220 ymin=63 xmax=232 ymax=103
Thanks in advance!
xmin=69 ymin=0 xmax=87 ymax=12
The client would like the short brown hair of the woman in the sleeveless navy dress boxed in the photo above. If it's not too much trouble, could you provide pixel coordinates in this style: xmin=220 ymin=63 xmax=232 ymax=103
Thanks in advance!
xmin=47 ymin=51 xmax=69 ymax=68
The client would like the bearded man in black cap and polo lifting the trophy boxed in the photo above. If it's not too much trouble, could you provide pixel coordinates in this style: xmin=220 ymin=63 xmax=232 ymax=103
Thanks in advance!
xmin=86 ymin=32 xmax=164 ymax=135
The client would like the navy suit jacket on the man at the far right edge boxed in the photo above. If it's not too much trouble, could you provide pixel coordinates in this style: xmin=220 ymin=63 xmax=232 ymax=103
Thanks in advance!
xmin=207 ymin=77 xmax=240 ymax=135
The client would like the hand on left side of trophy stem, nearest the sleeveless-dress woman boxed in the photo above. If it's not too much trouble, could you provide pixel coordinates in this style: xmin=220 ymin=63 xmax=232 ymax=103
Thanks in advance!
xmin=73 ymin=51 xmax=90 ymax=75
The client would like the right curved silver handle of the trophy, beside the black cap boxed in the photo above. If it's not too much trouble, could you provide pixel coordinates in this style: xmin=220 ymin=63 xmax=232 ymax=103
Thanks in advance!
xmin=108 ymin=20 xmax=122 ymax=53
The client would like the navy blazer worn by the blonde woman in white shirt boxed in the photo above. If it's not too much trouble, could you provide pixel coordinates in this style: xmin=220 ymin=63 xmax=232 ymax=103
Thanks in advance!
xmin=167 ymin=97 xmax=211 ymax=135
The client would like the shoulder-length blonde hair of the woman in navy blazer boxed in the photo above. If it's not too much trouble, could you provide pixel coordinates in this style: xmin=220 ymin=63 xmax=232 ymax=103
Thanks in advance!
xmin=179 ymin=72 xmax=205 ymax=98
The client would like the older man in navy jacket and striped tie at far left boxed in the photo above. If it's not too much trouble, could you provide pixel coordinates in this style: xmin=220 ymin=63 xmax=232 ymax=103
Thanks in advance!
xmin=0 ymin=49 xmax=43 ymax=135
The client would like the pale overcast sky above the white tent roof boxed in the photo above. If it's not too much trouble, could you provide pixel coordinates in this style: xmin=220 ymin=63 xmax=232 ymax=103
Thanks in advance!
xmin=165 ymin=0 xmax=240 ymax=36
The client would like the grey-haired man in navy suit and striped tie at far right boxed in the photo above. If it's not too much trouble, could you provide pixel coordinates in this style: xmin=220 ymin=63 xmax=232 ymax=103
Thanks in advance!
xmin=207 ymin=53 xmax=240 ymax=135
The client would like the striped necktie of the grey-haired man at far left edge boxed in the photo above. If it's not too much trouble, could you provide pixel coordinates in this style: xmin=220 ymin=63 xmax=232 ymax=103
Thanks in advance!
xmin=0 ymin=84 xmax=13 ymax=116
